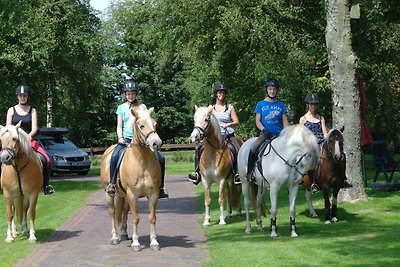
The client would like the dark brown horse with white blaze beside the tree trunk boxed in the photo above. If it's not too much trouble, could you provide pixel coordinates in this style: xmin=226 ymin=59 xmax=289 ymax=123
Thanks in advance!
xmin=304 ymin=128 xmax=346 ymax=224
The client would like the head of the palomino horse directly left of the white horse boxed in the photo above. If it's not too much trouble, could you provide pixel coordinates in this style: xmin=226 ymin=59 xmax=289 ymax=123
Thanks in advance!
xmin=190 ymin=105 xmax=212 ymax=143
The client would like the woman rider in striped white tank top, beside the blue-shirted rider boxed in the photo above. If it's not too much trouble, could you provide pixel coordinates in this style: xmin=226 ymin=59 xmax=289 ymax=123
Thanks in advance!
xmin=188 ymin=83 xmax=240 ymax=185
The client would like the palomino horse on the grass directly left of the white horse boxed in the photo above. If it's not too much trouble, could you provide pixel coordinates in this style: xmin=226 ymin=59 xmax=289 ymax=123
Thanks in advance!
xmin=190 ymin=106 xmax=241 ymax=226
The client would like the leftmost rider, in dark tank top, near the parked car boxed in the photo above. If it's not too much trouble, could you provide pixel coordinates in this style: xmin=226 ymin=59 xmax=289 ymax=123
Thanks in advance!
xmin=6 ymin=85 xmax=54 ymax=195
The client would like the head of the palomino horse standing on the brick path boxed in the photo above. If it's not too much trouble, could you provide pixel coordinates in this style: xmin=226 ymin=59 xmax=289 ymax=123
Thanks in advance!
xmin=131 ymin=108 xmax=162 ymax=150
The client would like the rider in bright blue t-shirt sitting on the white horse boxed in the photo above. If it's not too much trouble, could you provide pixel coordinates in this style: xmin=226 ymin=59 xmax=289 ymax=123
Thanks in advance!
xmin=246 ymin=79 xmax=289 ymax=182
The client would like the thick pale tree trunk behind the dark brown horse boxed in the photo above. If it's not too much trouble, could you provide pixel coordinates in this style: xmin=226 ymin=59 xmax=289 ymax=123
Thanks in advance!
xmin=325 ymin=0 xmax=366 ymax=201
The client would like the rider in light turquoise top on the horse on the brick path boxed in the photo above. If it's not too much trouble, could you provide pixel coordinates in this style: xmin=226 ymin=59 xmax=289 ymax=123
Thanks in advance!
xmin=106 ymin=80 xmax=168 ymax=198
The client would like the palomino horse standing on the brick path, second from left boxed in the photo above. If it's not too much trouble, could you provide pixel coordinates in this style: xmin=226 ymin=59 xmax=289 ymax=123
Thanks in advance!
xmin=100 ymin=107 xmax=162 ymax=251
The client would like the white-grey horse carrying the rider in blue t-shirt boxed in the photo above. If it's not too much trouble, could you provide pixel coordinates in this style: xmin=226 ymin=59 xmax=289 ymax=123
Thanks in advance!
xmin=238 ymin=125 xmax=320 ymax=237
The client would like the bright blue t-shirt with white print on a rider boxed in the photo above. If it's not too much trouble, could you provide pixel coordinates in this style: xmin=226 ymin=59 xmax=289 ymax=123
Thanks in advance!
xmin=254 ymin=99 xmax=287 ymax=135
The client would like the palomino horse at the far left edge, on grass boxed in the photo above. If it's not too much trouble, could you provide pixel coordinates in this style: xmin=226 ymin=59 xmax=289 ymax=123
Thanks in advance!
xmin=0 ymin=123 xmax=43 ymax=243
